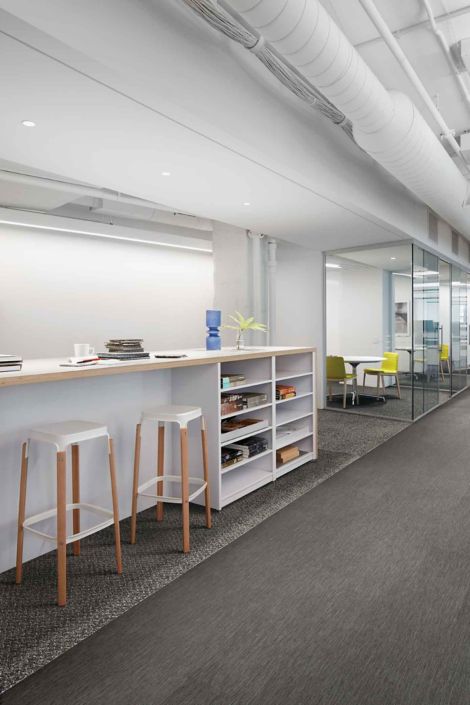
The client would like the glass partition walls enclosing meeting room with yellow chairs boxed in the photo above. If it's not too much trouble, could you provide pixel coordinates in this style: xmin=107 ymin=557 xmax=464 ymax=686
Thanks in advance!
xmin=325 ymin=243 xmax=470 ymax=420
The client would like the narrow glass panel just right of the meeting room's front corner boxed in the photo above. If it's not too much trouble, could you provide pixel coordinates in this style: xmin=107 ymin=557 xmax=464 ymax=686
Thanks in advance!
xmin=412 ymin=245 xmax=440 ymax=419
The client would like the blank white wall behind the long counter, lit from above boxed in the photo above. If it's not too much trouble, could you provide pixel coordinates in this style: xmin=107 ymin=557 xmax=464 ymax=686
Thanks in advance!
xmin=0 ymin=226 xmax=214 ymax=358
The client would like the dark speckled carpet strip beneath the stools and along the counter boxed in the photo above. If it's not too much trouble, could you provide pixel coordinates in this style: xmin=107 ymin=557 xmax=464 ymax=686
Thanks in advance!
xmin=0 ymin=411 xmax=407 ymax=692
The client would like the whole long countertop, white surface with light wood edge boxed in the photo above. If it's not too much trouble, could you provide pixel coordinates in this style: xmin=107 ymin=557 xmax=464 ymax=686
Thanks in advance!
xmin=0 ymin=347 xmax=316 ymax=387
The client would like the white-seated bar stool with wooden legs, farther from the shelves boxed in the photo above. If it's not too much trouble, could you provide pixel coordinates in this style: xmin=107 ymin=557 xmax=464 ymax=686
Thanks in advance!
xmin=16 ymin=421 xmax=122 ymax=607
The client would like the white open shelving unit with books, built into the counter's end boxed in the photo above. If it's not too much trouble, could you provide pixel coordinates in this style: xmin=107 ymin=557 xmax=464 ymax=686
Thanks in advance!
xmin=171 ymin=352 xmax=317 ymax=510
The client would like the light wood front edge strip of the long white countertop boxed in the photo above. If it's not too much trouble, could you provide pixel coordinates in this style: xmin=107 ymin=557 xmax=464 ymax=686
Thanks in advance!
xmin=0 ymin=348 xmax=316 ymax=388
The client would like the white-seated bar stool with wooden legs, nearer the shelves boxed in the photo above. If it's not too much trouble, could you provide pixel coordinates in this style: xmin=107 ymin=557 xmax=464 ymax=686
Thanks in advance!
xmin=131 ymin=404 xmax=212 ymax=553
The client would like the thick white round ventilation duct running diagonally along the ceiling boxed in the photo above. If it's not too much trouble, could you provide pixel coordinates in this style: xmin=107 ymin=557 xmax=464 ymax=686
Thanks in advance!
xmin=224 ymin=0 xmax=470 ymax=235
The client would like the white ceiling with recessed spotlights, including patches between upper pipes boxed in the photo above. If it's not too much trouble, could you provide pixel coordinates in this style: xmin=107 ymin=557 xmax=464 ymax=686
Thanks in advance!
xmin=0 ymin=0 xmax=470 ymax=249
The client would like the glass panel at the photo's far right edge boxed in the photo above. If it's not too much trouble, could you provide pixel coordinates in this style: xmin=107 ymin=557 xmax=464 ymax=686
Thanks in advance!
xmin=450 ymin=265 xmax=467 ymax=394
